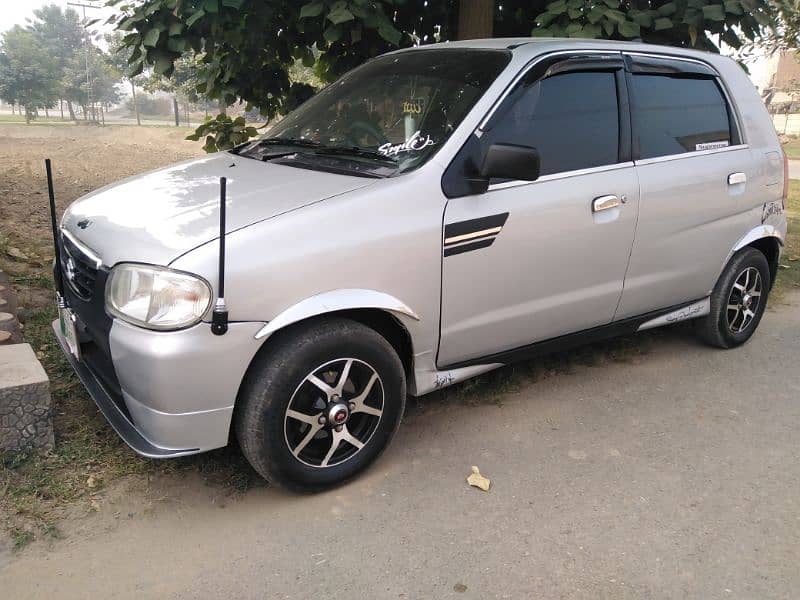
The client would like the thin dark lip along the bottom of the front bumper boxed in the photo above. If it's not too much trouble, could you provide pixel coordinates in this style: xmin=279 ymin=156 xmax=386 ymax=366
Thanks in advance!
xmin=53 ymin=320 xmax=201 ymax=458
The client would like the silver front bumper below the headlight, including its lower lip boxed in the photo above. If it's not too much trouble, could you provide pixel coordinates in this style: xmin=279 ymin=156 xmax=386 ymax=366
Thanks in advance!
xmin=53 ymin=317 xmax=263 ymax=458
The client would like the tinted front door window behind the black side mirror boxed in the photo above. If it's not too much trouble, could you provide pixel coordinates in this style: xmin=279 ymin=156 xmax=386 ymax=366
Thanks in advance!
xmin=491 ymin=71 xmax=620 ymax=175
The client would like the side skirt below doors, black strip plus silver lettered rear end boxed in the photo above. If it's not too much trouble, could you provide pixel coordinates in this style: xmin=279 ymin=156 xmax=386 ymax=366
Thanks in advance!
xmin=440 ymin=298 xmax=711 ymax=373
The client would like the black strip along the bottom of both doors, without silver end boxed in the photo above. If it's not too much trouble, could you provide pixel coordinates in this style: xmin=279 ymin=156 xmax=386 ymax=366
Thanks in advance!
xmin=437 ymin=298 xmax=702 ymax=371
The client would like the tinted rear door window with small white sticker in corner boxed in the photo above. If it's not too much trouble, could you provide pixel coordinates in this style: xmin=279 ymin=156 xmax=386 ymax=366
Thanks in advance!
xmin=630 ymin=74 xmax=732 ymax=158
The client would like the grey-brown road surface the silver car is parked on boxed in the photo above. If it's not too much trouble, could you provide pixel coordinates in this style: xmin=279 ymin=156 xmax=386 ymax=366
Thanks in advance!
xmin=0 ymin=293 xmax=800 ymax=600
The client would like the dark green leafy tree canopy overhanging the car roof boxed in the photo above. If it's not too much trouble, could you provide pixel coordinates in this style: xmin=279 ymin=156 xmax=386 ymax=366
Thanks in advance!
xmin=108 ymin=0 xmax=796 ymax=148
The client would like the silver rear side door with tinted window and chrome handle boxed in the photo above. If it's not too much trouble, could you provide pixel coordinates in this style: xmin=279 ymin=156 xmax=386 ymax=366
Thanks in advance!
xmin=617 ymin=55 xmax=758 ymax=319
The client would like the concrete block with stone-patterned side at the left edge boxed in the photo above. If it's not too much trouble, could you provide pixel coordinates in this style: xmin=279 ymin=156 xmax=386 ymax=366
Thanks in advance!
xmin=0 ymin=344 xmax=55 ymax=452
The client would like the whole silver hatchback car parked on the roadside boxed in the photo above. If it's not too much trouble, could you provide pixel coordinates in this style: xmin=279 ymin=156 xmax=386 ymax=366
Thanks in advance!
xmin=54 ymin=39 xmax=786 ymax=489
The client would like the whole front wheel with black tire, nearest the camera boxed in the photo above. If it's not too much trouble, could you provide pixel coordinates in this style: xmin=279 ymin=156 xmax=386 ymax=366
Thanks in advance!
xmin=235 ymin=318 xmax=406 ymax=491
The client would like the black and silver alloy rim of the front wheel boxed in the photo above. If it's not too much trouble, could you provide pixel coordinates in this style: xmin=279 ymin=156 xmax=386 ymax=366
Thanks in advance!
xmin=283 ymin=358 xmax=384 ymax=467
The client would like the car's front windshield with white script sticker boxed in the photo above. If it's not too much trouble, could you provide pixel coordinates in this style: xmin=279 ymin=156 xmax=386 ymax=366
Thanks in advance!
xmin=243 ymin=48 xmax=510 ymax=174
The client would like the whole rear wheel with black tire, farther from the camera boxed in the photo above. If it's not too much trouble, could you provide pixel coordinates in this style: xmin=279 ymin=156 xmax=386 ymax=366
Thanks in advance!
xmin=697 ymin=247 xmax=772 ymax=348
